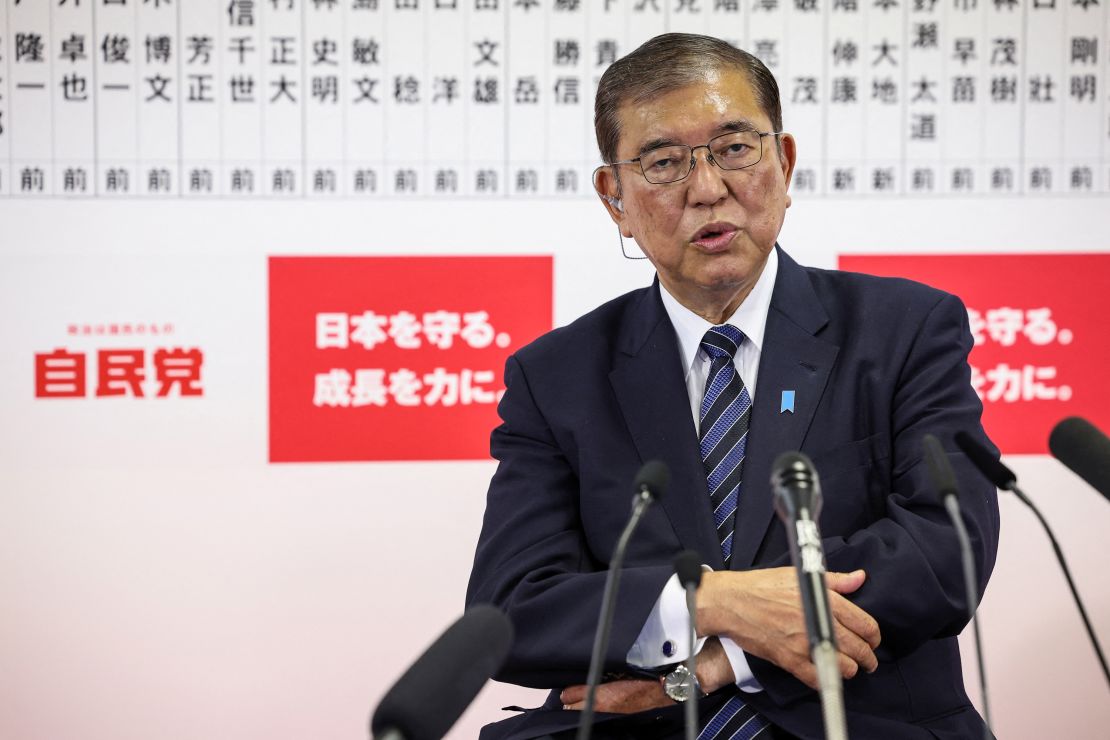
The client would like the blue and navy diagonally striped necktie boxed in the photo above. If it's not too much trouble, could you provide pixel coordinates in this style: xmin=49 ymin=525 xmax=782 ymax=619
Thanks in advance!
xmin=698 ymin=324 xmax=769 ymax=740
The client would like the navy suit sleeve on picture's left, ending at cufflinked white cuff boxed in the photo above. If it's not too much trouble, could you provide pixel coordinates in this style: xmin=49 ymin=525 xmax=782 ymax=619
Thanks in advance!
xmin=466 ymin=357 xmax=672 ymax=688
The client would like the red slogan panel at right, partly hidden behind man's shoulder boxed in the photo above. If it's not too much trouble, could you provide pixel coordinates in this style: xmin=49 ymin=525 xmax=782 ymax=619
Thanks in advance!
xmin=840 ymin=254 xmax=1110 ymax=455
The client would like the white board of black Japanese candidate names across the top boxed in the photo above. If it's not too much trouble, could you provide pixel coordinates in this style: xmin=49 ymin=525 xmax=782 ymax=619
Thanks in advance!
xmin=0 ymin=0 xmax=1110 ymax=199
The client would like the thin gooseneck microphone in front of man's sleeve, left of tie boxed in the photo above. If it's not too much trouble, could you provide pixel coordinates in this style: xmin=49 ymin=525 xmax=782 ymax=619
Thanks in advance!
xmin=577 ymin=460 xmax=670 ymax=740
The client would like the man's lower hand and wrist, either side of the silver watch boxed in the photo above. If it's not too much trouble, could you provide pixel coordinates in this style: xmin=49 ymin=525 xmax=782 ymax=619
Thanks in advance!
xmin=559 ymin=638 xmax=736 ymax=714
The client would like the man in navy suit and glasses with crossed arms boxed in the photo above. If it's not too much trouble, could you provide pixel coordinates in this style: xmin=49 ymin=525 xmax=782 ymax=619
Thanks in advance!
xmin=467 ymin=34 xmax=998 ymax=739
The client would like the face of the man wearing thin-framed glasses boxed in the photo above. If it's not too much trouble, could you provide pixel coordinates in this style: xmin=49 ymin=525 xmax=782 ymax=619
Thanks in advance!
xmin=597 ymin=65 xmax=795 ymax=321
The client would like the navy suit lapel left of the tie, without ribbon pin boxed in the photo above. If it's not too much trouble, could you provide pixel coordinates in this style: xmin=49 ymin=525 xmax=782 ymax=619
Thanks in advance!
xmin=609 ymin=283 xmax=724 ymax=569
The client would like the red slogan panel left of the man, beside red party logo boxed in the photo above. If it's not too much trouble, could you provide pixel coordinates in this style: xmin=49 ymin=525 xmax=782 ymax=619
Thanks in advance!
xmin=270 ymin=256 xmax=552 ymax=463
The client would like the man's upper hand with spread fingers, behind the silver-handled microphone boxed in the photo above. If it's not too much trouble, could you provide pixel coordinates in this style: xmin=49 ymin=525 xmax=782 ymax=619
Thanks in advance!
xmin=697 ymin=567 xmax=880 ymax=689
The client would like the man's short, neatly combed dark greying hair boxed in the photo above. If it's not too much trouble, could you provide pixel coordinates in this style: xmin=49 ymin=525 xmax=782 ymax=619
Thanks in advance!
xmin=594 ymin=33 xmax=783 ymax=162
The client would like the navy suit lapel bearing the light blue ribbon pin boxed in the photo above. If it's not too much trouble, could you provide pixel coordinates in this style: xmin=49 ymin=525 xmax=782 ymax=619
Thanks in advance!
xmin=729 ymin=247 xmax=839 ymax=570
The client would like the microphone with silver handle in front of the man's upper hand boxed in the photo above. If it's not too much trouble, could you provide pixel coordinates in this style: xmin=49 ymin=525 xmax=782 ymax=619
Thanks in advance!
xmin=770 ymin=453 xmax=848 ymax=740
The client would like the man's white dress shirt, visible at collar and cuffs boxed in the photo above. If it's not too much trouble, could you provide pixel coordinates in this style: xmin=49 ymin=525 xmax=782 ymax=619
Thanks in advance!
xmin=626 ymin=250 xmax=778 ymax=692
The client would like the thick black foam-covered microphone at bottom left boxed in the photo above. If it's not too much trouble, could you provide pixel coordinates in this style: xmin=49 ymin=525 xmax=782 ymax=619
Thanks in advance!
xmin=370 ymin=605 xmax=513 ymax=740
